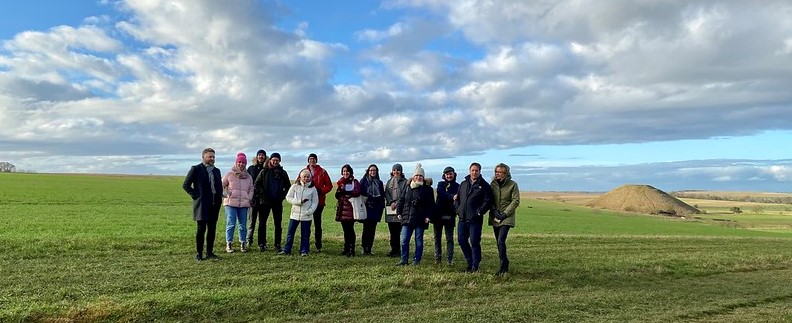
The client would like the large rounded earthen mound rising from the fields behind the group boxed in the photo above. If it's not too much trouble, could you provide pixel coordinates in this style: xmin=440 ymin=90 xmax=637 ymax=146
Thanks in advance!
xmin=586 ymin=185 xmax=700 ymax=216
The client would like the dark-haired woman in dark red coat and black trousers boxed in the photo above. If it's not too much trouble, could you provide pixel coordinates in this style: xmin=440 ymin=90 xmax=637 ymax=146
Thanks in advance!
xmin=335 ymin=164 xmax=360 ymax=257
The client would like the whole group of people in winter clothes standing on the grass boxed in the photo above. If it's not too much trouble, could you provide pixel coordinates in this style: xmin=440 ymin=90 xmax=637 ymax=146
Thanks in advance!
xmin=182 ymin=148 xmax=520 ymax=275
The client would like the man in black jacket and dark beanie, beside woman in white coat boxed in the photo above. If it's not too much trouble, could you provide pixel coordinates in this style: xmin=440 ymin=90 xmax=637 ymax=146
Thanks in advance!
xmin=253 ymin=153 xmax=291 ymax=252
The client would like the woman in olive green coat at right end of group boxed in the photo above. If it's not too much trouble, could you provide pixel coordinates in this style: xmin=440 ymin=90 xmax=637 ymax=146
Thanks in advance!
xmin=489 ymin=163 xmax=520 ymax=276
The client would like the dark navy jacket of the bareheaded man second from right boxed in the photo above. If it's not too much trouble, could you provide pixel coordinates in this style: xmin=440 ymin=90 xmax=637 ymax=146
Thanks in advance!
xmin=454 ymin=175 xmax=492 ymax=223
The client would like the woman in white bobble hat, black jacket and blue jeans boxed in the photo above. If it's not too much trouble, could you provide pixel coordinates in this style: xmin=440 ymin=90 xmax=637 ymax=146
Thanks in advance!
xmin=396 ymin=164 xmax=435 ymax=266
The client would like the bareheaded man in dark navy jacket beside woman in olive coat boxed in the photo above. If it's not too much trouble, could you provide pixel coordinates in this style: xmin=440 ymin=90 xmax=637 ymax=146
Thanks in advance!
xmin=454 ymin=163 xmax=492 ymax=272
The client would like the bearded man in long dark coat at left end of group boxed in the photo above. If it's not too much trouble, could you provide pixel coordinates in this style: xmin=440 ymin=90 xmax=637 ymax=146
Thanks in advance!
xmin=182 ymin=148 xmax=223 ymax=261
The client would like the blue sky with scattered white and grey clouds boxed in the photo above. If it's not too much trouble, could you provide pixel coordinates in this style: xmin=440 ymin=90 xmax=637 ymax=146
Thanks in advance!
xmin=0 ymin=0 xmax=792 ymax=192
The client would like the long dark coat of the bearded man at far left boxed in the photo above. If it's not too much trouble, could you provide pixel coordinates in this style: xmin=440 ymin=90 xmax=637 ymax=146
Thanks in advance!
xmin=182 ymin=163 xmax=223 ymax=221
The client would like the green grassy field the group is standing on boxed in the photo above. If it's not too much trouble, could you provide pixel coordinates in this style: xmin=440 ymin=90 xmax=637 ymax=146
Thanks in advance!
xmin=0 ymin=174 xmax=792 ymax=322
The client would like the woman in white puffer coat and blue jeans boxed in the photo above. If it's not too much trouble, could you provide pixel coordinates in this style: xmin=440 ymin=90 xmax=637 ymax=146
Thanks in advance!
xmin=280 ymin=169 xmax=319 ymax=257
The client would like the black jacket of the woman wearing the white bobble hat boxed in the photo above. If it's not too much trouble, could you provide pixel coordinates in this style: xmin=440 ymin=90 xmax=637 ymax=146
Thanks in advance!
xmin=396 ymin=183 xmax=435 ymax=229
